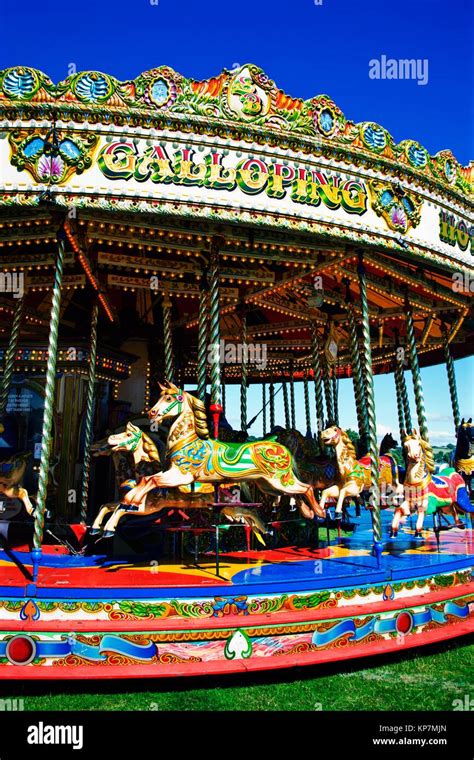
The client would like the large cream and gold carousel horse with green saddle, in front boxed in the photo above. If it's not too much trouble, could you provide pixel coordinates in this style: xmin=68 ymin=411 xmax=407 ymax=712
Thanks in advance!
xmin=118 ymin=383 xmax=324 ymax=519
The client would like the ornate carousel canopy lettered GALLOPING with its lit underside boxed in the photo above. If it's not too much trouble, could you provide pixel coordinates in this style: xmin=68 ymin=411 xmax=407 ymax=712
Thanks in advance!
xmin=0 ymin=64 xmax=474 ymax=382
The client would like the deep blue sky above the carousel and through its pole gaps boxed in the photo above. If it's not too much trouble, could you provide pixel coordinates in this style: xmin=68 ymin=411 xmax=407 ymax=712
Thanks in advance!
xmin=0 ymin=0 xmax=474 ymax=443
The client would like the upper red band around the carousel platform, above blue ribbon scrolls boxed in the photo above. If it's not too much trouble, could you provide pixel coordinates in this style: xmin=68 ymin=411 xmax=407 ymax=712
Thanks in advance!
xmin=0 ymin=581 xmax=474 ymax=633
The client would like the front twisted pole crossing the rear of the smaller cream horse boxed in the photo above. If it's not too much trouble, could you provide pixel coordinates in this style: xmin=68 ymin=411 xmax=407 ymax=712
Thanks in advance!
xmin=357 ymin=252 xmax=382 ymax=548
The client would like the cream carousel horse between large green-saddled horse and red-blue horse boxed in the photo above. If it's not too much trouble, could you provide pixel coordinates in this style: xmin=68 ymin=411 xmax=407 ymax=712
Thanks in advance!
xmin=320 ymin=425 xmax=403 ymax=517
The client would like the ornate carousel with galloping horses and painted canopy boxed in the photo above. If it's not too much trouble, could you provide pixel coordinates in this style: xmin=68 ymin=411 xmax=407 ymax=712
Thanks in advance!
xmin=0 ymin=64 xmax=474 ymax=679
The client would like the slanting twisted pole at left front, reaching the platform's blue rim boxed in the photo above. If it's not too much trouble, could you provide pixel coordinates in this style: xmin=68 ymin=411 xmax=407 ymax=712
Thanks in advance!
xmin=33 ymin=230 xmax=65 ymax=552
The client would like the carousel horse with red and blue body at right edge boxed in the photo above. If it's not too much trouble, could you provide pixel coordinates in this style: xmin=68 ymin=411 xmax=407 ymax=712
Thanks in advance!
xmin=391 ymin=428 xmax=474 ymax=538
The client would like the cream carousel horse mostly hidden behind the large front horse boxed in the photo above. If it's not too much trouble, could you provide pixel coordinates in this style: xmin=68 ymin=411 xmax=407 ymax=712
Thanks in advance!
xmin=89 ymin=422 xmax=267 ymax=543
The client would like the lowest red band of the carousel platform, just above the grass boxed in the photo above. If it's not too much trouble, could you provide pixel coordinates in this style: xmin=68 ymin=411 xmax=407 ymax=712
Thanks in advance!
xmin=0 ymin=620 xmax=474 ymax=681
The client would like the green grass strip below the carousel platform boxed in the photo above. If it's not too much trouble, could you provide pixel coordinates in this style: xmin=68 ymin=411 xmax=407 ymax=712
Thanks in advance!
xmin=0 ymin=637 xmax=474 ymax=711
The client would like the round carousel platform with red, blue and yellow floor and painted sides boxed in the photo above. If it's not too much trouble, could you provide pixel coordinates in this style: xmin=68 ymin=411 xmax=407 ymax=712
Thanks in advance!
xmin=0 ymin=513 xmax=474 ymax=679
